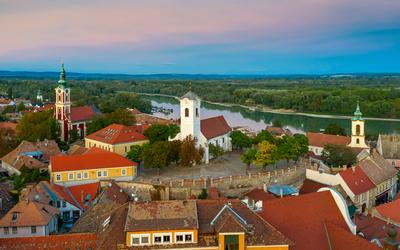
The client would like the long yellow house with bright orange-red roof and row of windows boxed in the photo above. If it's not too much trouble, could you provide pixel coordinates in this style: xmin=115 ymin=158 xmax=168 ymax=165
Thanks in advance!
xmin=49 ymin=148 xmax=137 ymax=185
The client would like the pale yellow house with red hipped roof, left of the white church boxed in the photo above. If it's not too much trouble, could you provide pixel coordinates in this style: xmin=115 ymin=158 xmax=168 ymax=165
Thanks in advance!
xmin=85 ymin=123 xmax=148 ymax=155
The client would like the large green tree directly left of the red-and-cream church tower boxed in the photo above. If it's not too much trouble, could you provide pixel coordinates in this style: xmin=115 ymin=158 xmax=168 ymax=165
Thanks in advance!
xmin=17 ymin=110 xmax=60 ymax=141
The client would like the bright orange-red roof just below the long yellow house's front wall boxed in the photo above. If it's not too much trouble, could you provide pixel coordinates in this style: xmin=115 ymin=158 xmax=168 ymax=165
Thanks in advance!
xmin=52 ymin=182 xmax=100 ymax=209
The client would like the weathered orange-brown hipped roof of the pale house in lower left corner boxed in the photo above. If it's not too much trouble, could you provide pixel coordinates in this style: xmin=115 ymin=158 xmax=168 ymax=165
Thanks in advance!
xmin=0 ymin=201 xmax=58 ymax=227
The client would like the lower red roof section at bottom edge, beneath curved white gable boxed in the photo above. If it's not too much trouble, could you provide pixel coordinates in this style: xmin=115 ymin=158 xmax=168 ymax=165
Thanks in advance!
xmin=325 ymin=223 xmax=380 ymax=250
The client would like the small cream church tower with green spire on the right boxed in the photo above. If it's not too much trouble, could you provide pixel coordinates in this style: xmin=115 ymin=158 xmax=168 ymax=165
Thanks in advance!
xmin=349 ymin=102 xmax=369 ymax=148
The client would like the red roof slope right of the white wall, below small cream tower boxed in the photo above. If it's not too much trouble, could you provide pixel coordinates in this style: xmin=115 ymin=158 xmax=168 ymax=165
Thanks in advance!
xmin=339 ymin=166 xmax=375 ymax=195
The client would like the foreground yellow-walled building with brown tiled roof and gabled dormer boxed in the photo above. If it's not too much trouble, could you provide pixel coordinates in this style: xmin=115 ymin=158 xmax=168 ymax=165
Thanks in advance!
xmin=125 ymin=200 xmax=291 ymax=250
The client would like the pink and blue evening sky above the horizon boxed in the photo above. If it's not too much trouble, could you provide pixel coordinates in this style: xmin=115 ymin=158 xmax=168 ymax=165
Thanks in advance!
xmin=0 ymin=0 xmax=400 ymax=75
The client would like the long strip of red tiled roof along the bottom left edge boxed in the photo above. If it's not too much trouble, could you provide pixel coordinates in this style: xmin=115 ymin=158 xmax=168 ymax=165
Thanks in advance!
xmin=0 ymin=233 xmax=96 ymax=250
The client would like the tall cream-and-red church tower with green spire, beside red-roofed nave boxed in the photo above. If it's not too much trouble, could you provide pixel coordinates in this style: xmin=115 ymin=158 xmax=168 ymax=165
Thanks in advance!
xmin=55 ymin=63 xmax=71 ymax=140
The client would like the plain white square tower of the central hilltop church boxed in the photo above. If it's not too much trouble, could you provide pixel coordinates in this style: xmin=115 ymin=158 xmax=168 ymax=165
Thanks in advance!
xmin=180 ymin=91 xmax=201 ymax=143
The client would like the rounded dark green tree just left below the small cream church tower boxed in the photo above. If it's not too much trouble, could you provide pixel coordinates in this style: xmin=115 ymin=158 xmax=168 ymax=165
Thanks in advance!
xmin=321 ymin=144 xmax=357 ymax=168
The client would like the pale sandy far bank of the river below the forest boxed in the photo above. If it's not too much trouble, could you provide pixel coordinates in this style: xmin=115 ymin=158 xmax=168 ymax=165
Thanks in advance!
xmin=137 ymin=93 xmax=400 ymax=122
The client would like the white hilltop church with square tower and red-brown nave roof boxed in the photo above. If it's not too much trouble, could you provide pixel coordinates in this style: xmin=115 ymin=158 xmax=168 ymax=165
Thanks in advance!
xmin=173 ymin=91 xmax=232 ymax=163
